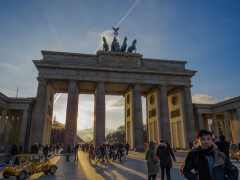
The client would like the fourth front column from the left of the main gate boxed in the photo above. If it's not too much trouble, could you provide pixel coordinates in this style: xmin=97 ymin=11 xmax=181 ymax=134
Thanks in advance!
xmin=133 ymin=84 xmax=143 ymax=151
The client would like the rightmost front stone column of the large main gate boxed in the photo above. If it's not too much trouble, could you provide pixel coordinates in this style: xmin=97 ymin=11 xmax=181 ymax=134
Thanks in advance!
xmin=183 ymin=86 xmax=195 ymax=142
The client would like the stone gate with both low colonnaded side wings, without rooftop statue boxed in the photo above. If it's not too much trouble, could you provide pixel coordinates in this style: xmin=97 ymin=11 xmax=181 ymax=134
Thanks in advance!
xmin=0 ymin=51 xmax=240 ymax=151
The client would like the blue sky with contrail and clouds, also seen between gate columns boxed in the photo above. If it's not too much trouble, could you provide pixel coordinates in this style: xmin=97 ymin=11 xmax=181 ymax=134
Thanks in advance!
xmin=0 ymin=0 xmax=240 ymax=138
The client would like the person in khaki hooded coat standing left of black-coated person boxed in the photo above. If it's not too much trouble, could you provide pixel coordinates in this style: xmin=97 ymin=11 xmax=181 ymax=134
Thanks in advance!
xmin=146 ymin=141 xmax=159 ymax=180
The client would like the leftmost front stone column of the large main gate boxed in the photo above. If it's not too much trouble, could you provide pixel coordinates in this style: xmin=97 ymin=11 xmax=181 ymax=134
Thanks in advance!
xmin=30 ymin=79 xmax=47 ymax=145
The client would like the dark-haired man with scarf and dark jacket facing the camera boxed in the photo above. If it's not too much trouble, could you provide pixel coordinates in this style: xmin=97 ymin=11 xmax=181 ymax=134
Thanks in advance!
xmin=180 ymin=129 xmax=238 ymax=180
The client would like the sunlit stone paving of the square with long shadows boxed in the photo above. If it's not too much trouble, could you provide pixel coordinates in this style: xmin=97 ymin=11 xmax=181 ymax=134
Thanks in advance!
xmin=0 ymin=151 xmax=240 ymax=180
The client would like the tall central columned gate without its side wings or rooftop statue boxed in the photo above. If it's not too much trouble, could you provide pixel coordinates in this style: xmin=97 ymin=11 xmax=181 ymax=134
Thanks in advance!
xmin=30 ymin=48 xmax=196 ymax=151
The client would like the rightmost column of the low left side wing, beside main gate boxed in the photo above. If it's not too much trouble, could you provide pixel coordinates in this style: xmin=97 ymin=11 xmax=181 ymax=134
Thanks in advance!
xmin=19 ymin=110 xmax=28 ymax=152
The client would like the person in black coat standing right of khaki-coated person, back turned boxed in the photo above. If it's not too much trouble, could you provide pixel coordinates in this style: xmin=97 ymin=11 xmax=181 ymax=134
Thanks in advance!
xmin=157 ymin=140 xmax=172 ymax=180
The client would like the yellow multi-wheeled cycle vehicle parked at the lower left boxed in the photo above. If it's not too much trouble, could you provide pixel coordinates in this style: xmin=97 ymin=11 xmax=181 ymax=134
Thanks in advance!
xmin=2 ymin=154 xmax=57 ymax=180
